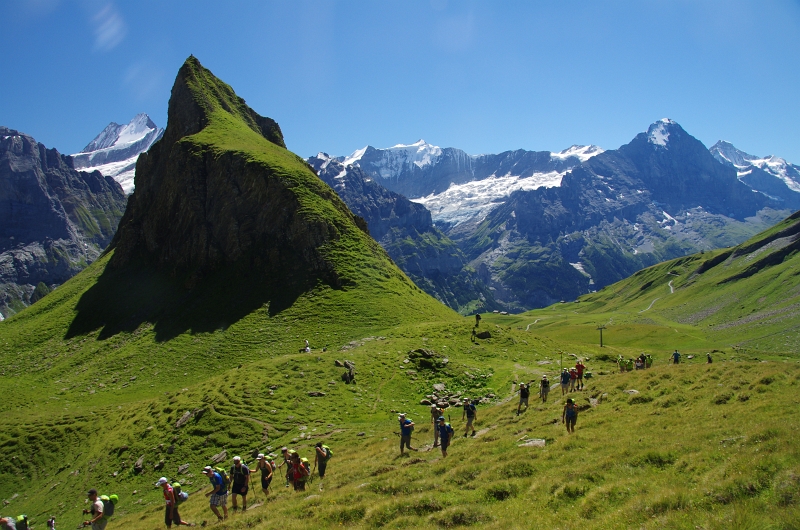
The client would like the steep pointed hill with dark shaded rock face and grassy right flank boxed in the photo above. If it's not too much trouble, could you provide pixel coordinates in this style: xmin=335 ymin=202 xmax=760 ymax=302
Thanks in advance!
xmin=80 ymin=57 xmax=450 ymax=337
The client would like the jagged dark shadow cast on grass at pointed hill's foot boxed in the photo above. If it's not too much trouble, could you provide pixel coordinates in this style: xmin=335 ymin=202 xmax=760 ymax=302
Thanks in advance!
xmin=65 ymin=256 xmax=313 ymax=342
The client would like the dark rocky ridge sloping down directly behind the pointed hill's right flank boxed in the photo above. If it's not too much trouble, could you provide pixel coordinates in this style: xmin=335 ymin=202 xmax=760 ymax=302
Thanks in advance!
xmin=308 ymin=153 xmax=498 ymax=312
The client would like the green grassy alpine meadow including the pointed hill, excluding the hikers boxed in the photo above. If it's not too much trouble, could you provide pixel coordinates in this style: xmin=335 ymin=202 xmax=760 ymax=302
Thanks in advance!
xmin=0 ymin=56 xmax=800 ymax=530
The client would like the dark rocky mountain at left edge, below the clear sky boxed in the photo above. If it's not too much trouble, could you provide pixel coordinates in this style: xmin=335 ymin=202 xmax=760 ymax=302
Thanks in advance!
xmin=0 ymin=127 xmax=126 ymax=316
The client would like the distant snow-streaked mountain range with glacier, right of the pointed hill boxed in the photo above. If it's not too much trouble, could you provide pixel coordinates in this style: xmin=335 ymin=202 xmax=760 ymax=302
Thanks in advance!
xmin=309 ymin=119 xmax=800 ymax=312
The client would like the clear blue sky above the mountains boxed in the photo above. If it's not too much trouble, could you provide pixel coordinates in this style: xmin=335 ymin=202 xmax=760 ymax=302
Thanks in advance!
xmin=0 ymin=0 xmax=800 ymax=164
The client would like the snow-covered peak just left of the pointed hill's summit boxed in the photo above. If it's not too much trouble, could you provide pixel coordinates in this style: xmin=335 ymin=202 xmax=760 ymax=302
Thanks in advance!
xmin=72 ymin=114 xmax=164 ymax=194
